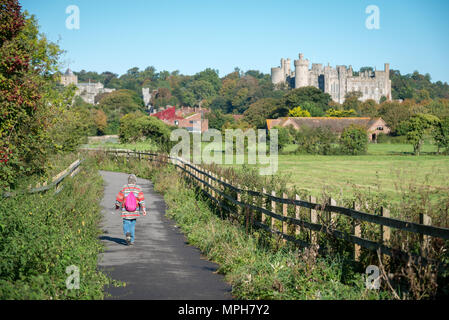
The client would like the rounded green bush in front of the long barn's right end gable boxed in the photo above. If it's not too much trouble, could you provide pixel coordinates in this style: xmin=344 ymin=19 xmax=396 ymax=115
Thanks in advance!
xmin=340 ymin=125 xmax=368 ymax=155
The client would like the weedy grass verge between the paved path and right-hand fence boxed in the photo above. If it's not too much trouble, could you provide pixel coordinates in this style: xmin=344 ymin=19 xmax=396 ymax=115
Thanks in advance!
xmin=92 ymin=153 xmax=390 ymax=299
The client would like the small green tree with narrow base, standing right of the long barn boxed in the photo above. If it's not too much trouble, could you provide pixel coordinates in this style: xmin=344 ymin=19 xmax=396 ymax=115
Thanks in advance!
xmin=406 ymin=113 xmax=439 ymax=156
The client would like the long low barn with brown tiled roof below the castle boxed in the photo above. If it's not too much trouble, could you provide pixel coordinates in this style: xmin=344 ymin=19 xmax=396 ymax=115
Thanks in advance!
xmin=267 ymin=117 xmax=391 ymax=142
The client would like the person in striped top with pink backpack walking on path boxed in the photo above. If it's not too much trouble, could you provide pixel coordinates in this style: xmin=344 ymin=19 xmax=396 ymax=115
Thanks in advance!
xmin=115 ymin=174 xmax=147 ymax=245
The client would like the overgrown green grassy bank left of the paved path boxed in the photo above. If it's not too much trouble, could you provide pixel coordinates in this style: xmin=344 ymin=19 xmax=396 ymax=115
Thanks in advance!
xmin=0 ymin=158 xmax=109 ymax=300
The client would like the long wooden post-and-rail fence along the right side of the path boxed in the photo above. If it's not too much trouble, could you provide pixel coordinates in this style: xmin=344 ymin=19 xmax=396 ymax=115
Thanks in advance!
xmin=95 ymin=150 xmax=449 ymax=269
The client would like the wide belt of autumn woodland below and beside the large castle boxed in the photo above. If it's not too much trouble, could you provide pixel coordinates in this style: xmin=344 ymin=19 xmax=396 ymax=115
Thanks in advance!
xmin=71 ymin=67 xmax=449 ymax=134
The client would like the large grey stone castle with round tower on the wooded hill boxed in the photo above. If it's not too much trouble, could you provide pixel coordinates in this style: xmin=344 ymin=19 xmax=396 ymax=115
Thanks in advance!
xmin=271 ymin=53 xmax=391 ymax=103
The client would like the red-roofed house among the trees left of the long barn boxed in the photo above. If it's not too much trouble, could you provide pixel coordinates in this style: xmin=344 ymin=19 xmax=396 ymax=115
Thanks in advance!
xmin=151 ymin=106 xmax=209 ymax=132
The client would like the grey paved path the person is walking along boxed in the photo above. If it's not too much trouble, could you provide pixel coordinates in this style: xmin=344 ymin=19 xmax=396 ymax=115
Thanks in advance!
xmin=99 ymin=171 xmax=232 ymax=300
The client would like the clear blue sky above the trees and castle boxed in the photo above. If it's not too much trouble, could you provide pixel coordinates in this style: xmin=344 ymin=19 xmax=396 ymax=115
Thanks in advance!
xmin=19 ymin=0 xmax=449 ymax=82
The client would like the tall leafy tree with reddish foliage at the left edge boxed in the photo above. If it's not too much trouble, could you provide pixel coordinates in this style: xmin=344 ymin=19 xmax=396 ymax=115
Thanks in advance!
xmin=0 ymin=0 xmax=93 ymax=191
